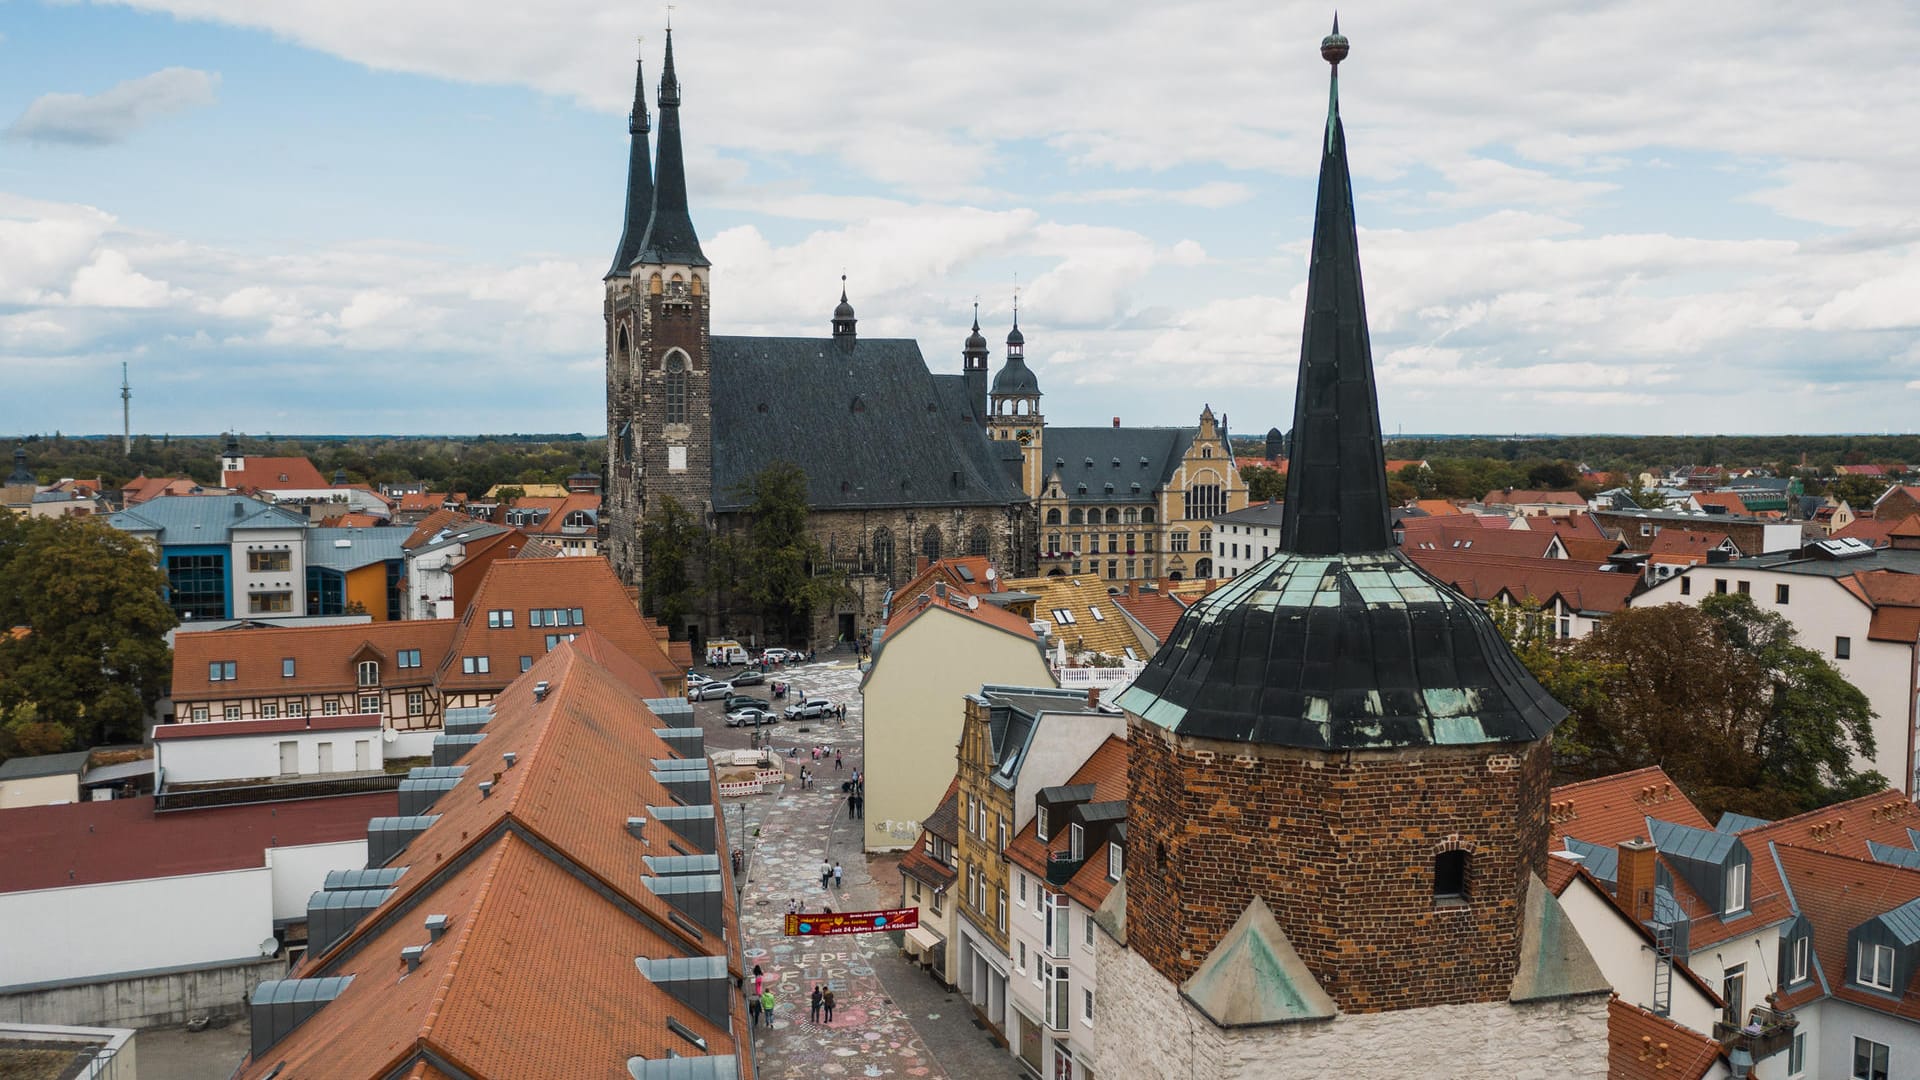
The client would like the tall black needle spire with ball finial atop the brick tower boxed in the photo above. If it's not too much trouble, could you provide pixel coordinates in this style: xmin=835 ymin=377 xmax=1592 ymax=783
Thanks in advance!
xmin=1281 ymin=19 xmax=1394 ymax=555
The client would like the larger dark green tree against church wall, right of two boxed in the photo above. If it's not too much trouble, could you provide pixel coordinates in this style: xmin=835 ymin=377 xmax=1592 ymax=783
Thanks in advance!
xmin=735 ymin=461 xmax=847 ymax=640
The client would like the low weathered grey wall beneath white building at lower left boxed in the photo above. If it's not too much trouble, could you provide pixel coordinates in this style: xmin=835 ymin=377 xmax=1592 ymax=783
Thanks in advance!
xmin=0 ymin=959 xmax=286 ymax=1028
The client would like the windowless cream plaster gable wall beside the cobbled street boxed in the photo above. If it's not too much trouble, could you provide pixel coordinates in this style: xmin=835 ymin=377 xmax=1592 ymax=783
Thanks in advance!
xmin=860 ymin=609 xmax=1058 ymax=851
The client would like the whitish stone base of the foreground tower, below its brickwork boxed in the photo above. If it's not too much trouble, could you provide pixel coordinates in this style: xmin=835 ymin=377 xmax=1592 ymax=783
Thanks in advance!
xmin=1087 ymin=930 xmax=1607 ymax=1080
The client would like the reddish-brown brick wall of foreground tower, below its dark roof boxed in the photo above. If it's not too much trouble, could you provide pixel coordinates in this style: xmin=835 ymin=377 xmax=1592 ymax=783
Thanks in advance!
xmin=1102 ymin=717 xmax=1549 ymax=1013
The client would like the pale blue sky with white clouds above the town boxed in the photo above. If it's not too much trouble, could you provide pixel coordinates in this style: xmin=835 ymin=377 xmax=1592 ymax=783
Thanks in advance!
xmin=0 ymin=0 xmax=1920 ymax=432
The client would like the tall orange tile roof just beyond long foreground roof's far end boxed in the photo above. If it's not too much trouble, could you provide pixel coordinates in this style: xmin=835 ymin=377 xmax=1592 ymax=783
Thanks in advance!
xmin=438 ymin=557 xmax=679 ymax=698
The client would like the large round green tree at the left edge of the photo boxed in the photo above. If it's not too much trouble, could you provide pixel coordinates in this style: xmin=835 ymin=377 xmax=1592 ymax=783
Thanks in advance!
xmin=0 ymin=517 xmax=177 ymax=746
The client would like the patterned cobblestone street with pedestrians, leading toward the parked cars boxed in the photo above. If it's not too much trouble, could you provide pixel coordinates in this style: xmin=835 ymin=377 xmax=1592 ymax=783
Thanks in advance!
xmin=697 ymin=661 xmax=1018 ymax=1080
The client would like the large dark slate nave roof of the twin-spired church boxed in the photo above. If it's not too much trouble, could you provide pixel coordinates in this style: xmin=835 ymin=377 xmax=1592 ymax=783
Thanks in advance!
xmin=710 ymin=334 xmax=1052 ymax=511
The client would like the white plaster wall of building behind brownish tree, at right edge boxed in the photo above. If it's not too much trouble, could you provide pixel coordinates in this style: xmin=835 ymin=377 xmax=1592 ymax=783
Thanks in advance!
xmin=1632 ymin=559 xmax=1914 ymax=792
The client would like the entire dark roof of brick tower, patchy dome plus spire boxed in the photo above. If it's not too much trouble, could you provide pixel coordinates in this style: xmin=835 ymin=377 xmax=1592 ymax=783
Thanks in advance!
xmin=1119 ymin=27 xmax=1567 ymax=749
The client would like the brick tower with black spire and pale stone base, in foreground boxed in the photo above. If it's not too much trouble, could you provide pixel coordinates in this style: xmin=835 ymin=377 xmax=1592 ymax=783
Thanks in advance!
xmin=1096 ymin=25 xmax=1609 ymax=1080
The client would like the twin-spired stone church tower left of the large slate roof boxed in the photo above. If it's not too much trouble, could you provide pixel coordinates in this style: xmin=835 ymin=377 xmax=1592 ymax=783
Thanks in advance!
xmin=605 ymin=31 xmax=712 ymax=582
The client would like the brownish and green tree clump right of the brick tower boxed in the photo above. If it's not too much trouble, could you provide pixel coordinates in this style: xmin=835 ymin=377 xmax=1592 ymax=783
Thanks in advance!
xmin=1543 ymin=594 xmax=1885 ymax=819
